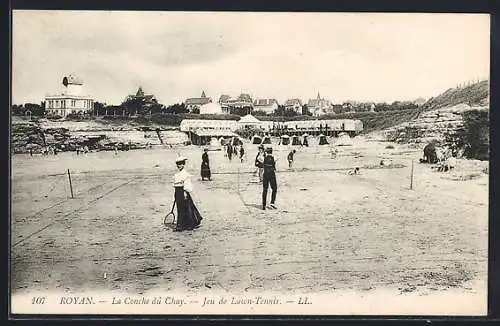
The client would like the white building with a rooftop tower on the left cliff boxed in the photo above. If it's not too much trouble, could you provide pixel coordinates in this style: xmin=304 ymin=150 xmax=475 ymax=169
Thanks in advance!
xmin=45 ymin=75 xmax=94 ymax=117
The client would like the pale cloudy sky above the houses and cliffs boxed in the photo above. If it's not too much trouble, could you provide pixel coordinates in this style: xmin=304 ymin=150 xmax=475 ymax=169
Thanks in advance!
xmin=12 ymin=11 xmax=490 ymax=105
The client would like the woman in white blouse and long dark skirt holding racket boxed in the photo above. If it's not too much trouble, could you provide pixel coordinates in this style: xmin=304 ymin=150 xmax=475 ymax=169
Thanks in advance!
xmin=174 ymin=157 xmax=202 ymax=231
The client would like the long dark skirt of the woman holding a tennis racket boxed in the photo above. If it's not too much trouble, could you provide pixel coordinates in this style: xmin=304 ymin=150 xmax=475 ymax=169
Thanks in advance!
xmin=175 ymin=187 xmax=202 ymax=231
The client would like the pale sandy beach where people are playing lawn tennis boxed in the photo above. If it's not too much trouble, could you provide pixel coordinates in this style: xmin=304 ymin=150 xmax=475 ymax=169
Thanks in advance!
xmin=11 ymin=136 xmax=488 ymax=304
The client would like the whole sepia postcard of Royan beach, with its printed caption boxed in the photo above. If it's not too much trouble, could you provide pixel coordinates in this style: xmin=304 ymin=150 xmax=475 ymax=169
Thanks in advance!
xmin=9 ymin=10 xmax=490 ymax=316
